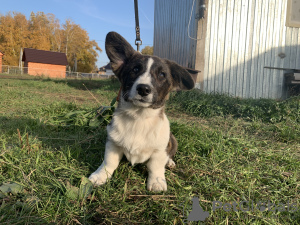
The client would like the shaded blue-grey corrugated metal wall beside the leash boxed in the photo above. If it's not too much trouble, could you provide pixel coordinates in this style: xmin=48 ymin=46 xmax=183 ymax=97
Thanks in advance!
xmin=153 ymin=0 xmax=197 ymax=69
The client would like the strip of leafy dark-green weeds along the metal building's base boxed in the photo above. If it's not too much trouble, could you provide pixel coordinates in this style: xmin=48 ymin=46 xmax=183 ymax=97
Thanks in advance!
xmin=169 ymin=90 xmax=300 ymax=142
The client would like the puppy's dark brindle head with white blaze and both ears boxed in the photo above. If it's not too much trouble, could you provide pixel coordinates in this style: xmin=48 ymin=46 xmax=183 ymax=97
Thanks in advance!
xmin=105 ymin=32 xmax=195 ymax=108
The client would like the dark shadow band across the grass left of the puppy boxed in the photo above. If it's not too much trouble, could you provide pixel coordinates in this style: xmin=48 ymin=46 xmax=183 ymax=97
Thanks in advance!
xmin=0 ymin=117 xmax=106 ymax=172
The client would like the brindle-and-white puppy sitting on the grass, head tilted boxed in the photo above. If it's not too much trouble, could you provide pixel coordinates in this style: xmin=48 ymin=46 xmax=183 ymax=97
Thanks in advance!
xmin=89 ymin=32 xmax=195 ymax=192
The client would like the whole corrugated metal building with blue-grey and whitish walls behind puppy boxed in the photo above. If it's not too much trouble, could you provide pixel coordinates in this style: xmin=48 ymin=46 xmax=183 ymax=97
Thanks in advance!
xmin=154 ymin=0 xmax=300 ymax=99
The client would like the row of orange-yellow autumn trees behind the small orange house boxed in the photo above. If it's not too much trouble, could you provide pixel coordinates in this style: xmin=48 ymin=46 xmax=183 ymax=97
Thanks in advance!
xmin=0 ymin=12 xmax=102 ymax=72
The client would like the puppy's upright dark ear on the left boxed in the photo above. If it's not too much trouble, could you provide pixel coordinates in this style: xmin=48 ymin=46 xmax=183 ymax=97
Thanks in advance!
xmin=105 ymin=32 xmax=135 ymax=79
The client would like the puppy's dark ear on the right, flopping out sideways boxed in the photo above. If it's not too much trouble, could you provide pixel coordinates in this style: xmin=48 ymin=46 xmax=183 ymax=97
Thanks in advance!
xmin=166 ymin=60 xmax=195 ymax=90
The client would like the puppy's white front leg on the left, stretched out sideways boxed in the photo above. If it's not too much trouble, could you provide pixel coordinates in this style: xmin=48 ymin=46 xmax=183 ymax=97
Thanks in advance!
xmin=89 ymin=141 xmax=124 ymax=185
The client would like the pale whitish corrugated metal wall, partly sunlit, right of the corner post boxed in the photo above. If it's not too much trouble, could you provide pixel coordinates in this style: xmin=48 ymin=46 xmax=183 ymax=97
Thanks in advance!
xmin=204 ymin=0 xmax=300 ymax=99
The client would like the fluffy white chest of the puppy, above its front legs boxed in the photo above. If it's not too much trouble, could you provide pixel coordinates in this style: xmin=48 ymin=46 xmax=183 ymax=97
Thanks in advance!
xmin=107 ymin=110 xmax=170 ymax=164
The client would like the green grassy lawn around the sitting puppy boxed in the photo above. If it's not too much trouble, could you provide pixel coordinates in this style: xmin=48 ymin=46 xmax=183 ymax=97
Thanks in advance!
xmin=0 ymin=74 xmax=300 ymax=224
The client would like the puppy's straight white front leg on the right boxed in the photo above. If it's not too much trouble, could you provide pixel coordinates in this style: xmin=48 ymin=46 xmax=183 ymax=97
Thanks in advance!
xmin=147 ymin=151 xmax=169 ymax=192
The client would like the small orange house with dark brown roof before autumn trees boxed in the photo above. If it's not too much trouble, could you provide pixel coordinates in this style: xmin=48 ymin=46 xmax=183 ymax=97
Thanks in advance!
xmin=22 ymin=48 xmax=68 ymax=78
